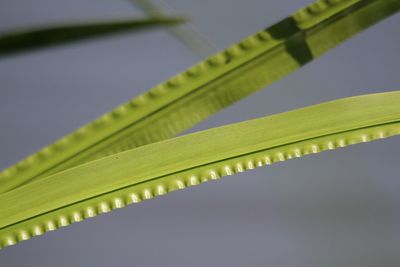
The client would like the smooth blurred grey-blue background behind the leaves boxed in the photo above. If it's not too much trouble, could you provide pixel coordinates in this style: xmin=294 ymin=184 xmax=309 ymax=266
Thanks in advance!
xmin=0 ymin=0 xmax=400 ymax=267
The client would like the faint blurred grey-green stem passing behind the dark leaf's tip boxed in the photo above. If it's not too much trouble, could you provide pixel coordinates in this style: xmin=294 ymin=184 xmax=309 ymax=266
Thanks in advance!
xmin=130 ymin=0 xmax=215 ymax=58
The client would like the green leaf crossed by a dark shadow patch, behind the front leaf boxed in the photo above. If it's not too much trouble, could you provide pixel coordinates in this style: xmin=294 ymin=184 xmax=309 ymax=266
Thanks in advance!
xmin=0 ymin=0 xmax=400 ymax=193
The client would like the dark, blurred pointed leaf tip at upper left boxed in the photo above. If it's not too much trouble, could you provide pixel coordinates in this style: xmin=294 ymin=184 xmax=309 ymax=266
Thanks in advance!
xmin=0 ymin=17 xmax=184 ymax=56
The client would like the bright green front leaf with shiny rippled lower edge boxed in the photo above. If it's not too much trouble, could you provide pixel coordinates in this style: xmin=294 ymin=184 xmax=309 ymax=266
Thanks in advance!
xmin=0 ymin=91 xmax=400 ymax=247
